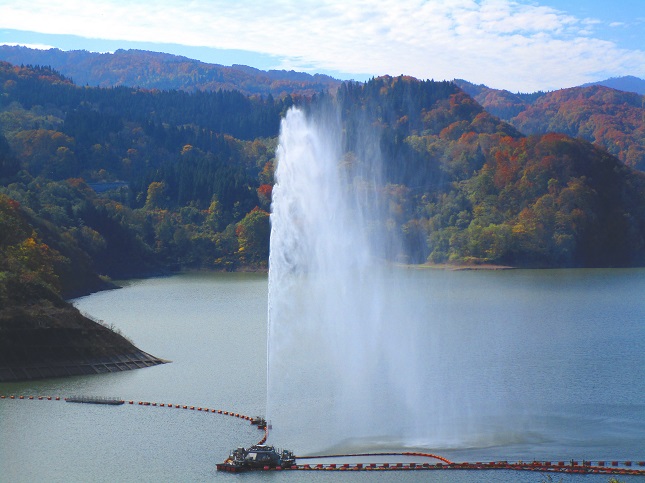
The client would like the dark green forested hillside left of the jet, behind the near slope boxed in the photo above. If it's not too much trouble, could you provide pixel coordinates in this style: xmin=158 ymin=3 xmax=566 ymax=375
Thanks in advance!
xmin=0 ymin=63 xmax=282 ymax=288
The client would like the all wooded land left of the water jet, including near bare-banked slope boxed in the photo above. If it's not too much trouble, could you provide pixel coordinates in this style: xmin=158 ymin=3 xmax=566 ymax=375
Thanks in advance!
xmin=0 ymin=62 xmax=280 ymax=381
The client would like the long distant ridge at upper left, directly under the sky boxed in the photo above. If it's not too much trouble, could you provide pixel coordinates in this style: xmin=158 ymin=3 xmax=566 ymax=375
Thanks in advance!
xmin=0 ymin=45 xmax=341 ymax=97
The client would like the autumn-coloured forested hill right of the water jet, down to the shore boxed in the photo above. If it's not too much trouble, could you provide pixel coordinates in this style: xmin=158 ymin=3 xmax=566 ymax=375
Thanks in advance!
xmin=339 ymin=77 xmax=645 ymax=267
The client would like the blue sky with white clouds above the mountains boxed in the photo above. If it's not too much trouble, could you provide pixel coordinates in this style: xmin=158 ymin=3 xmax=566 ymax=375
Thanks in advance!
xmin=0 ymin=0 xmax=645 ymax=92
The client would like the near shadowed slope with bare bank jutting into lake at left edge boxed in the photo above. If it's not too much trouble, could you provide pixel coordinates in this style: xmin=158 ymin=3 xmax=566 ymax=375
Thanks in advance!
xmin=0 ymin=194 xmax=164 ymax=382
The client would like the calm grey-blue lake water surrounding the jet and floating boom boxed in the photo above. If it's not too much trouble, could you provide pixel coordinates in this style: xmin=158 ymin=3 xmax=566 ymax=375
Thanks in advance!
xmin=0 ymin=269 xmax=645 ymax=482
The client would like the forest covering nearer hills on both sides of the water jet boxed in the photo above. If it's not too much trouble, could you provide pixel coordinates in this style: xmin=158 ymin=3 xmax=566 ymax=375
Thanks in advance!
xmin=0 ymin=59 xmax=645 ymax=314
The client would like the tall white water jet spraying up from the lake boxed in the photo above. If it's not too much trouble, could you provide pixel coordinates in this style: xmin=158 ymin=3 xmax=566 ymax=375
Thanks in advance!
xmin=267 ymin=104 xmax=508 ymax=454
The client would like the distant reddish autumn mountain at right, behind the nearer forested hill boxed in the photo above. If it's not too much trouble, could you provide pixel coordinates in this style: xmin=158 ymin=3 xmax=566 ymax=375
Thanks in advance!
xmin=454 ymin=77 xmax=645 ymax=171
